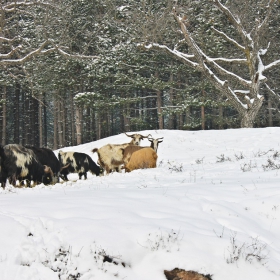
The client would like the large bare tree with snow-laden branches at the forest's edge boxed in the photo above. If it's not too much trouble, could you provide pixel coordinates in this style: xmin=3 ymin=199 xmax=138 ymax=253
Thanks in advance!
xmin=144 ymin=0 xmax=280 ymax=127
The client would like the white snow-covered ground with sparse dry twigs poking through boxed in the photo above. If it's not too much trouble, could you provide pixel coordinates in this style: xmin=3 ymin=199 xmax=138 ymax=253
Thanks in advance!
xmin=0 ymin=128 xmax=280 ymax=280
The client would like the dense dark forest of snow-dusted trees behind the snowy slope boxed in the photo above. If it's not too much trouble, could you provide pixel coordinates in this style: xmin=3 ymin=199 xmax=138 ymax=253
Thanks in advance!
xmin=0 ymin=0 xmax=280 ymax=149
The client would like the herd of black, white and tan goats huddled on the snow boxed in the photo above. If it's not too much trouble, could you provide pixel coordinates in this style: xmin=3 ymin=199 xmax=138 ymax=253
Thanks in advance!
xmin=0 ymin=133 xmax=163 ymax=189
